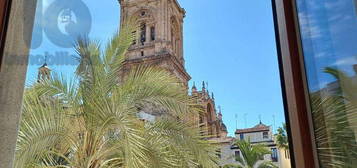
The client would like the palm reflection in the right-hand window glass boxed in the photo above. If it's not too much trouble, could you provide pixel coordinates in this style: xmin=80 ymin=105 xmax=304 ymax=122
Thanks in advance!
xmin=310 ymin=67 xmax=357 ymax=168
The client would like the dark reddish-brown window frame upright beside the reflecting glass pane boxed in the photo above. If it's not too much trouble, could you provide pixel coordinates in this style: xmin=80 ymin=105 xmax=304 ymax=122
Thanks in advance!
xmin=272 ymin=0 xmax=319 ymax=168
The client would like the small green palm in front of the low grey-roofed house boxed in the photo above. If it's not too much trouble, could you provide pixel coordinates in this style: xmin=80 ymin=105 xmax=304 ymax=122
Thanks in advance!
xmin=224 ymin=140 xmax=277 ymax=168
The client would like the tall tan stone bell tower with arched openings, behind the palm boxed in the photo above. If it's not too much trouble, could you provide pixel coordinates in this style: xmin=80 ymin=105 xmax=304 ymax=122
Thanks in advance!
xmin=119 ymin=0 xmax=191 ymax=87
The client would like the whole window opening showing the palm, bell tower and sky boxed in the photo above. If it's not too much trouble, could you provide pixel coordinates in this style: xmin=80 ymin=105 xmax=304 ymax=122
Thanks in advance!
xmin=11 ymin=0 xmax=291 ymax=168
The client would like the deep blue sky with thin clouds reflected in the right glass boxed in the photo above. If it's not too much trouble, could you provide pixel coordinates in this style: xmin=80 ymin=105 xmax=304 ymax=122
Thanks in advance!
xmin=297 ymin=0 xmax=357 ymax=92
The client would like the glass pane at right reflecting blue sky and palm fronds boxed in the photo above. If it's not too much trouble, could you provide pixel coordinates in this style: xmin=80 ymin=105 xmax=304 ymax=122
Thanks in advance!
xmin=297 ymin=0 xmax=357 ymax=167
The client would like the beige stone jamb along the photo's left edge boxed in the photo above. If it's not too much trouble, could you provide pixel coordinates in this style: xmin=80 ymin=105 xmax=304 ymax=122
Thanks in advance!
xmin=0 ymin=0 xmax=36 ymax=168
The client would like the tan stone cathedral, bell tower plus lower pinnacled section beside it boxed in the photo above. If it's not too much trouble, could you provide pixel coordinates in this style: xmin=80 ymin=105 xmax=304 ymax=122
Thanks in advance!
xmin=119 ymin=0 xmax=227 ymax=138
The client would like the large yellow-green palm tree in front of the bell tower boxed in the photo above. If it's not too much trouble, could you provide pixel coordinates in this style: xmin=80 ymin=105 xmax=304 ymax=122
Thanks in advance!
xmin=15 ymin=18 xmax=217 ymax=168
